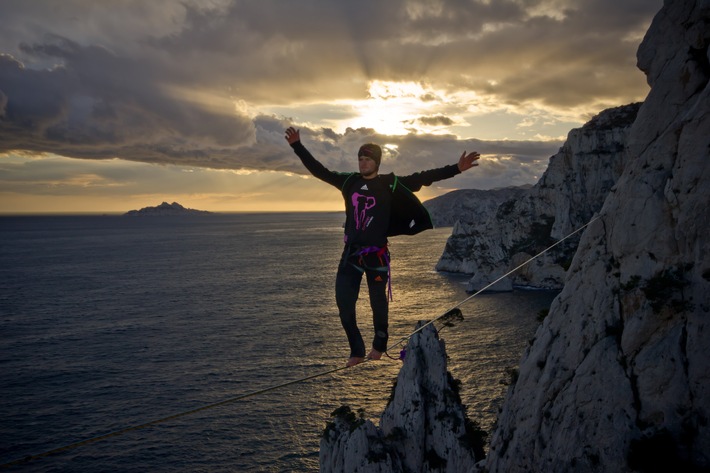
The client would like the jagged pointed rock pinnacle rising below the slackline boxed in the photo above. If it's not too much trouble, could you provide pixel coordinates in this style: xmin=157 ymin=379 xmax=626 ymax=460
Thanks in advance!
xmin=320 ymin=325 xmax=483 ymax=473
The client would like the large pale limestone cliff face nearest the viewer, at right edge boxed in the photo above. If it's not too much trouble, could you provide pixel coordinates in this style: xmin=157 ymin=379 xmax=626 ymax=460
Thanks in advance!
xmin=484 ymin=0 xmax=710 ymax=473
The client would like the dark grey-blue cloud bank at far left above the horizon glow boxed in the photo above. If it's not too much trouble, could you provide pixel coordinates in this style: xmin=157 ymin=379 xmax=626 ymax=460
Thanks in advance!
xmin=0 ymin=36 xmax=254 ymax=164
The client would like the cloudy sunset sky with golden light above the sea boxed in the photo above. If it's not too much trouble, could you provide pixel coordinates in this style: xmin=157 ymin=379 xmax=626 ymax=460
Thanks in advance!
xmin=0 ymin=0 xmax=662 ymax=213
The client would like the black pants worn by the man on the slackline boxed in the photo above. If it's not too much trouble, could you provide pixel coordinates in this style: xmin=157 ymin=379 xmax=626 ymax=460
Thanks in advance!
xmin=335 ymin=248 xmax=389 ymax=357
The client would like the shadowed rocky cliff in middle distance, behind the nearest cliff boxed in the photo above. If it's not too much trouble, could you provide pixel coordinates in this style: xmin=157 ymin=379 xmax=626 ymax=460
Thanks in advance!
xmin=436 ymin=104 xmax=640 ymax=291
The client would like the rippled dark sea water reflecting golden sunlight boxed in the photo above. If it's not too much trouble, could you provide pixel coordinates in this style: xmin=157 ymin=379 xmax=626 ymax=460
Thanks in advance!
xmin=0 ymin=213 xmax=555 ymax=472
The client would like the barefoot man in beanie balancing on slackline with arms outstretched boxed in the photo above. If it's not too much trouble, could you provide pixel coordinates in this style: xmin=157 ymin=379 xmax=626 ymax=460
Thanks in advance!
xmin=286 ymin=127 xmax=481 ymax=366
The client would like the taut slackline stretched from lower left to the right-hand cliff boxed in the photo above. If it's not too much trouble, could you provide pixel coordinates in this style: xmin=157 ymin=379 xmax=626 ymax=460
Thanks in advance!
xmin=0 ymin=215 xmax=600 ymax=468
